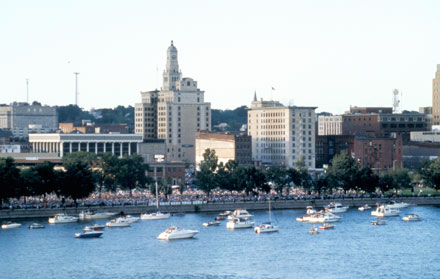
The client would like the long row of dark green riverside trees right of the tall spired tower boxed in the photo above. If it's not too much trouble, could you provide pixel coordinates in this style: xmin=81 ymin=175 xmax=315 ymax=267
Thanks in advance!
xmin=195 ymin=149 xmax=440 ymax=197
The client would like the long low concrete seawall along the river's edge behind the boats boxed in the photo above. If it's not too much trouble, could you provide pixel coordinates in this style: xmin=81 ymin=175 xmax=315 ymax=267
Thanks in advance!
xmin=0 ymin=197 xmax=440 ymax=220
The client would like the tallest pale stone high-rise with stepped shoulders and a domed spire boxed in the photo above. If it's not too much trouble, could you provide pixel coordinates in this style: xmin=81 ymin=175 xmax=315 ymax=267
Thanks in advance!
xmin=135 ymin=41 xmax=211 ymax=164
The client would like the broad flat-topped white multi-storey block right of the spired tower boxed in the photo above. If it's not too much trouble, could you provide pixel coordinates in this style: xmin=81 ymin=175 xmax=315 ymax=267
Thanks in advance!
xmin=248 ymin=98 xmax=316 ymax=168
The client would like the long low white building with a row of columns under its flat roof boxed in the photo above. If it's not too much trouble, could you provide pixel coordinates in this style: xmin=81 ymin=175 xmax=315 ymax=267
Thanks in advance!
xmin=29 ymin=133 xmax=143 ymax=157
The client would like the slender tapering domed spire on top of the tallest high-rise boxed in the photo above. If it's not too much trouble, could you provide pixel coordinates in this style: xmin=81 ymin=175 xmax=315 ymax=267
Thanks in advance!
xmin=162 ymin=41 xmax=182 ymax=91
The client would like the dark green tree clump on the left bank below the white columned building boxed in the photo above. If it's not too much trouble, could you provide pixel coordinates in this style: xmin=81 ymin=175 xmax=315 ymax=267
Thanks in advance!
xmin=0 ymin=152 xmax=152 ymax=206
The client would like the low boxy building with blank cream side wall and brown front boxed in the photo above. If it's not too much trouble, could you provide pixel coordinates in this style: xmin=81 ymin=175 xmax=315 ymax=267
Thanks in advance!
xmin=195 ymin=131 xmax=252 ymax=167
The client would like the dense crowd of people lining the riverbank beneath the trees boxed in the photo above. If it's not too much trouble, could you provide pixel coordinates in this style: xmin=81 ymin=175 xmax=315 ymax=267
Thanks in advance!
xmin=2 ymin=187 xmax=398 ymax=209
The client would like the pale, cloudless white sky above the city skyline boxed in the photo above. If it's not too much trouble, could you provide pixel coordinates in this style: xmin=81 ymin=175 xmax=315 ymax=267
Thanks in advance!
xmin=0 ymin=0 xmax=440 ymax=114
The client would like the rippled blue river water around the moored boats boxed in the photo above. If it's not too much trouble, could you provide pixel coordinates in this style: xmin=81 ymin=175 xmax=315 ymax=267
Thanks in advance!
xmin=0 ymin=206 xmax=440 ymax=279
